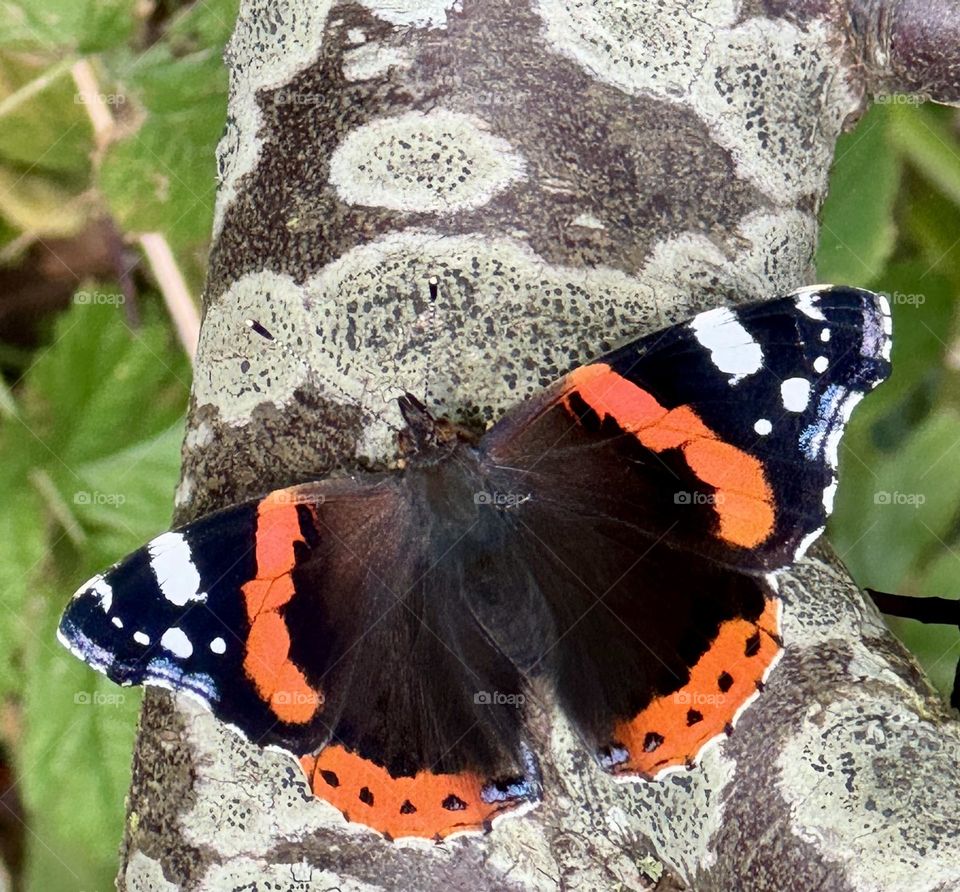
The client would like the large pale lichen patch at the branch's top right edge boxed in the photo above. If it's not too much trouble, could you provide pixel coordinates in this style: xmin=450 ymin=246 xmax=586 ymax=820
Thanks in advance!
xmin=538 ymin=0 xmax=858 ymax=204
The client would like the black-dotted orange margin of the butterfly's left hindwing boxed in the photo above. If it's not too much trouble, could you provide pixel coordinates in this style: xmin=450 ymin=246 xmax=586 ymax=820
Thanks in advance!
xmin=300 ymin=745 xmax=526 ymax=839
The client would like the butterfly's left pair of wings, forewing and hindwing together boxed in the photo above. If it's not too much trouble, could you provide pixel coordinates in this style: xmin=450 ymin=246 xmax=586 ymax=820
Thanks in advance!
xmin=59 ymin=475 xmax=539 ymax=837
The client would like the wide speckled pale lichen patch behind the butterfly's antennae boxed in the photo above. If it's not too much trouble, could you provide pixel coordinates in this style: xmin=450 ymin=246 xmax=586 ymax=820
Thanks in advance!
xmin=194 ymin=230 xmax=658 ymax=459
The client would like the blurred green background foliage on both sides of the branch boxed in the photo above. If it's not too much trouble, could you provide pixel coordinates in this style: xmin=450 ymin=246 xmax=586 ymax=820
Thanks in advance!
xmin=0 ymin=0 xmax=960 ymax=892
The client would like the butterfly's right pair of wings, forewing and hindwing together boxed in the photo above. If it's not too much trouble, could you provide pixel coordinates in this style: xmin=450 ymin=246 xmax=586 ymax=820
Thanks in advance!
xmin=482 ymin=289 xmax=889 ymax=775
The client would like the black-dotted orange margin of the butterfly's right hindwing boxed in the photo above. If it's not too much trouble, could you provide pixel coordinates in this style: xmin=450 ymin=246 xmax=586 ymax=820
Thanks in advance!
xmin=612 ymin=599 xmax=782 ymax=777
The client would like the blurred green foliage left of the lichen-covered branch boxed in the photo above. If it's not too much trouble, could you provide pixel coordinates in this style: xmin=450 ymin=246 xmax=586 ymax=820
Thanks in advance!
xmin=0 ymin=0 xmax=238 ymax=892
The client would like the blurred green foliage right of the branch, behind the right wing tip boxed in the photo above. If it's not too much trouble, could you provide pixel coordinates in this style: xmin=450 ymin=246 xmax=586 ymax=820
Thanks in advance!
xmin=817 ymin=103 xmax=960 ymax=695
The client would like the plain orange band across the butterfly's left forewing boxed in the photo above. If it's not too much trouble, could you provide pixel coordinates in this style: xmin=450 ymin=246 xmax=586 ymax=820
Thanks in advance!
xmin=242 ymin=490 xmax=323 ymax=724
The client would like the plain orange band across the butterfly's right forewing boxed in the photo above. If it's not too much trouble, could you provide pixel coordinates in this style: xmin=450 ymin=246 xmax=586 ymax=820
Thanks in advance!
xmin=564 ymin=363 xmax=775 ymax=548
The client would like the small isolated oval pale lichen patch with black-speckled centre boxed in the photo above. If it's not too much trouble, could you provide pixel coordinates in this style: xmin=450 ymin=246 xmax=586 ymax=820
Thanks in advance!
xmin=330 ymin=109 xmax=526 ymax=213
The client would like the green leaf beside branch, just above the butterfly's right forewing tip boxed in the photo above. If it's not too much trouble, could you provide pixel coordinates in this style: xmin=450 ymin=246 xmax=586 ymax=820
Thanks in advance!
xmin=816 ymin=106 xmax=900 ymax=285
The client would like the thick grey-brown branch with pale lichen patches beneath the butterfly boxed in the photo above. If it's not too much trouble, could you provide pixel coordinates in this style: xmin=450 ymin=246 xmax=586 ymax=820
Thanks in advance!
xmin=120 ymin=0 xmax=960 ymax=892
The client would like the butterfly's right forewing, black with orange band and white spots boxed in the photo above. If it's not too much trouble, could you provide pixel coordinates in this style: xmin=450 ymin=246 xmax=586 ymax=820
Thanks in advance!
xmin=484 ymin=288 xmax=890 ymax=572
